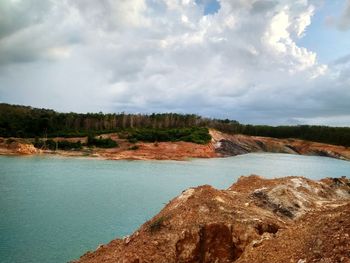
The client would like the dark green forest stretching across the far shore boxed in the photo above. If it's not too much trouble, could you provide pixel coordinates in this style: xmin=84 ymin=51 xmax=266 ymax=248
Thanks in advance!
xmin=0 ymin=103 xmax=350 ymax=147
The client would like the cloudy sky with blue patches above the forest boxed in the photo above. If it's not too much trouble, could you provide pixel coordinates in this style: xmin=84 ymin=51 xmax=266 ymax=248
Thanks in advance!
xmin=0 ymin=0 xmax=350 ymax=126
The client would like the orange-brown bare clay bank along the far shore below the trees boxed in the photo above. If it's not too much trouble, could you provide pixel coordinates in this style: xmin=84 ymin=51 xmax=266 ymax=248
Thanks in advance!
xmin=0 ymin=129 xmax=350 ymax=160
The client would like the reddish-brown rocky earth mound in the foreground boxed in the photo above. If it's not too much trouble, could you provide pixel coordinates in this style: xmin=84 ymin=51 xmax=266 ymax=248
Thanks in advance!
xmin=76 ymin=176 xmax=350 ymax=263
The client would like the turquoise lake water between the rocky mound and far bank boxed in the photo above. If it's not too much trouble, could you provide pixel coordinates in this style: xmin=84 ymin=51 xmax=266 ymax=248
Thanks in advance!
xmin=0 ymin=154 xmax=350 ymax=263
